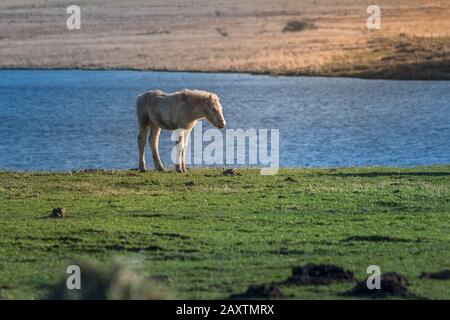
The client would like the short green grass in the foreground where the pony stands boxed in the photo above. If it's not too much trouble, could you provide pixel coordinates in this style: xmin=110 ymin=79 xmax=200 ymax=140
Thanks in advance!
xmin=0 ymin=166 xmax=450 ymax=299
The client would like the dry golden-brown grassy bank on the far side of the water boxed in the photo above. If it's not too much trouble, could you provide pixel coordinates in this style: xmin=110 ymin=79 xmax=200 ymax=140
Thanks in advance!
xmin=0 ymin=0 xmax=450 ymax=79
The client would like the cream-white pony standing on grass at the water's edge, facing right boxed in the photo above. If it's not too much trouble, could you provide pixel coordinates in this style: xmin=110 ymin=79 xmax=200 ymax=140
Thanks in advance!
xmin=136 ymin=89 xmax=226 ymax=172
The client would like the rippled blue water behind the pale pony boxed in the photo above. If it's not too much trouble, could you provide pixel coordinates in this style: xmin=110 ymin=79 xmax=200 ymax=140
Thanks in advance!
xmin=0 ymin=70 xmax=450 ymax=170
